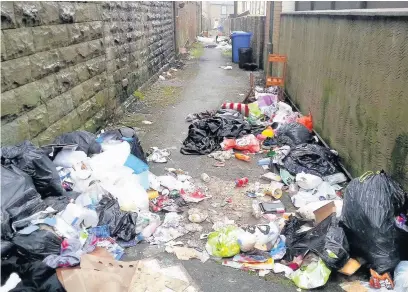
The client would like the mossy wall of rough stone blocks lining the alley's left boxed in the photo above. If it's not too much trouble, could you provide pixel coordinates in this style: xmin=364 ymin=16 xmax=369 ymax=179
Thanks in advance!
xmin=1 ymin=1 xmax=174 ymax=145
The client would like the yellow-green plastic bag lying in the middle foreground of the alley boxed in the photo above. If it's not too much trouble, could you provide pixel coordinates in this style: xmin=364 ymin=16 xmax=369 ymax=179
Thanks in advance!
xmin=205 ymin=225 xmax=241 ymax=258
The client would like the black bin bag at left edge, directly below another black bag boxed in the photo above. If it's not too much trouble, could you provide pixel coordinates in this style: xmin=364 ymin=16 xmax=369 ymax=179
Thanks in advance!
xmin=1 ymin=165 xmax=46 ymax=239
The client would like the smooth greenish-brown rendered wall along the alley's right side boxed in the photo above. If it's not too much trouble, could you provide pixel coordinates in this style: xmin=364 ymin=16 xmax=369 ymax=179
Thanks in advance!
xmin=279 ymin=10 xmax=408 ymax=189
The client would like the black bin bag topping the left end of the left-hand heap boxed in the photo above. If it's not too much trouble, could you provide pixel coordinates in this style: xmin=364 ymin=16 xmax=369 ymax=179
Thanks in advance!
xmin=1 ymin=140 xmax=65 ymax=198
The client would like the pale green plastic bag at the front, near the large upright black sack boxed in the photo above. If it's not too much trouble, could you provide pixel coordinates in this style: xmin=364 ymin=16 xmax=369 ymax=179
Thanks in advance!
xmin=291 ymin=258 xmax=331 ymax=289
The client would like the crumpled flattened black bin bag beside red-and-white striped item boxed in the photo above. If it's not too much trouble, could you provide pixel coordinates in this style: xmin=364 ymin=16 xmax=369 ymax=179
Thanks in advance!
xmin=180 ymin=110 xmax=251 ymax=155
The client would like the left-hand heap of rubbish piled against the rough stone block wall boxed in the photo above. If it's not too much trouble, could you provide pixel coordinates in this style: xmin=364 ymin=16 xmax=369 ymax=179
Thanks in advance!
xmin=1 ymin=127 xmax=217 ymax=291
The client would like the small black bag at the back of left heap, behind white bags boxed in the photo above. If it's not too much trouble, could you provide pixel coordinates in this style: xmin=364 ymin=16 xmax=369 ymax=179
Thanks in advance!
xmin=53 ymin=131 xmax=102 ymax=156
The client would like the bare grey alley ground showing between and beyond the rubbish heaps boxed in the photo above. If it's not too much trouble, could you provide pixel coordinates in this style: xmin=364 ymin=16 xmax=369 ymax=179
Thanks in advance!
xmin=121 ymin=47 xmax=350 ymax=292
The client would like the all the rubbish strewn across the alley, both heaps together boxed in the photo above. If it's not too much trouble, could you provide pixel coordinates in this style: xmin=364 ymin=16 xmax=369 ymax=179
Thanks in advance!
xmin=1 ymin=81 xmax=408 ymax=292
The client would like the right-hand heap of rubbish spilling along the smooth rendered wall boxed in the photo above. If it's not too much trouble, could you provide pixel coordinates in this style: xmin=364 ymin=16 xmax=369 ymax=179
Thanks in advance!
xmin=180 ymin=87 xmax=408 ymax=292
